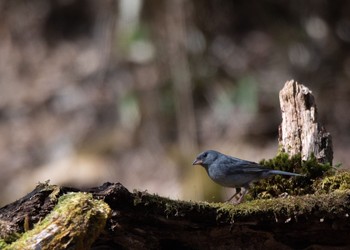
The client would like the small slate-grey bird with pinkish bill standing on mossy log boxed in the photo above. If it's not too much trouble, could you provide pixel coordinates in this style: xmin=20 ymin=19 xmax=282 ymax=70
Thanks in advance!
xmin=192 ymin=150 xmax=304 ymax=204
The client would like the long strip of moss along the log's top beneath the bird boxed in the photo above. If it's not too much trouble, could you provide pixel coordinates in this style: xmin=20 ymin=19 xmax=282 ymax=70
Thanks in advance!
xmin=134 ymin=186 xmax=350 ymax=226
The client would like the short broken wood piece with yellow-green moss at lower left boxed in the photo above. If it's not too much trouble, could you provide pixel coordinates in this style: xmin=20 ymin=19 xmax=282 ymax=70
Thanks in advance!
xmin=5 ymin=193 xmax=110 ymax=249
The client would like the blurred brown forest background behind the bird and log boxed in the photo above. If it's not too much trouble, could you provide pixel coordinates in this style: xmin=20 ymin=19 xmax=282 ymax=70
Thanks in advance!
xmin=0 ymin=0 xmax=350 ymax=205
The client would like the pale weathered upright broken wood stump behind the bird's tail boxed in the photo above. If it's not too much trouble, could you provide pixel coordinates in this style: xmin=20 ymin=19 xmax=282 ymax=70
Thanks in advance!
xmin=279 ymin=80 xmax=333 ymax=164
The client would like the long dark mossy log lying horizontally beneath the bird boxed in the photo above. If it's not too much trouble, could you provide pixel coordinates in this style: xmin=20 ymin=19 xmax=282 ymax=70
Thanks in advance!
xmin=0 ymin=183 xmax=350 ymax=249
